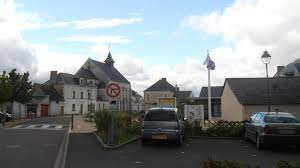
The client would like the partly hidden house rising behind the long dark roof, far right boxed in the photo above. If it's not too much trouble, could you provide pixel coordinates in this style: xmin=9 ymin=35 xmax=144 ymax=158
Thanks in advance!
xmin=274 ymin=59 xmax=300 ymax=77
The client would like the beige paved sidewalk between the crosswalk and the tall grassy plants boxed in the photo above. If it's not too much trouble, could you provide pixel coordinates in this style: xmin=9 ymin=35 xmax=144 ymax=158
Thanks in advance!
xmin=71 ymin=115 xmax=96 ymax=133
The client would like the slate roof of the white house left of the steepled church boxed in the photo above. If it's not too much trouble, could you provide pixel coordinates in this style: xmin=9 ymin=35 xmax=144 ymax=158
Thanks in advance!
xmin=44 ymin=73 xmax=79 ymax=85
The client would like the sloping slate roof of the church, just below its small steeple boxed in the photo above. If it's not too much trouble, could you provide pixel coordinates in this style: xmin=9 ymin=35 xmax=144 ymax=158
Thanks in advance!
xmin=91 ymin=59 xmax=130 ymax=83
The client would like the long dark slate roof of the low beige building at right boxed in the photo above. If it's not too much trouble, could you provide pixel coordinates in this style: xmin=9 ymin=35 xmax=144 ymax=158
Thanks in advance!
xmin=225 ymin=77 xmax=300 ymax=105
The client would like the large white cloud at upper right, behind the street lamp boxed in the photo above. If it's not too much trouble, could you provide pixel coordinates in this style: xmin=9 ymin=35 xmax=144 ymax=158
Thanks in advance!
xmin=184 ymin=0 xmax=300 ymax=81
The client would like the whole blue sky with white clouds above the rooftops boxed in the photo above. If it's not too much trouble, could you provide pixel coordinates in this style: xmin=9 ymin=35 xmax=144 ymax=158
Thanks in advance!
xmin=0 ymin=0 xmax=300 ymax=96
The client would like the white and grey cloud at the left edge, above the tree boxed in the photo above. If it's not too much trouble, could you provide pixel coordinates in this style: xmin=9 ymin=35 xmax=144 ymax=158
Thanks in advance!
xmin=0 ymin=0 xmax=37 ymax=74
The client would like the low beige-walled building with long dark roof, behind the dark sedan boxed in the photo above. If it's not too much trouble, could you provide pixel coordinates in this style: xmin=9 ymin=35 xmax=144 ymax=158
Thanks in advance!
xmin=221 ymin=77 xmax=300 ymax=121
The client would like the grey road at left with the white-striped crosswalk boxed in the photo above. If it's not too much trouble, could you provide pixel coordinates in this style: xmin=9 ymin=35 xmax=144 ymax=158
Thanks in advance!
xmin=0 ymin=117 xmax=70 ymax=168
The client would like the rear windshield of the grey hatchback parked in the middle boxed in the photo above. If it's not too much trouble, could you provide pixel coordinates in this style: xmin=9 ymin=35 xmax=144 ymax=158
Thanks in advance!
xmin=145 ymin=110 xmax=177 ymax=121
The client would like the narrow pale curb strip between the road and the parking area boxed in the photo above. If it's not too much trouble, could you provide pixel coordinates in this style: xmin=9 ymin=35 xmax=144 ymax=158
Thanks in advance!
xmin=53 ymin=124 xmax=71 ymax=168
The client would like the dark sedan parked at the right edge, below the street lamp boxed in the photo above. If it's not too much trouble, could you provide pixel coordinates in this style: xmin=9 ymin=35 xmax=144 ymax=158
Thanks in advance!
xmin=244 ymin=112 xmax=300 ymax=149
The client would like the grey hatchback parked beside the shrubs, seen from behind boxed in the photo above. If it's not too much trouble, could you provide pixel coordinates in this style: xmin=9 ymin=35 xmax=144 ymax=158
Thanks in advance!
xmin=142 ymin=108 xmax=184 ymax=145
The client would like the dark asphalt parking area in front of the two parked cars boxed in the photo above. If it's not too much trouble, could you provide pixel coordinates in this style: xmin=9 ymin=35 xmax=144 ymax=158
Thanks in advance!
xmin=66 ymin=134 xmax=300 ymax=168
